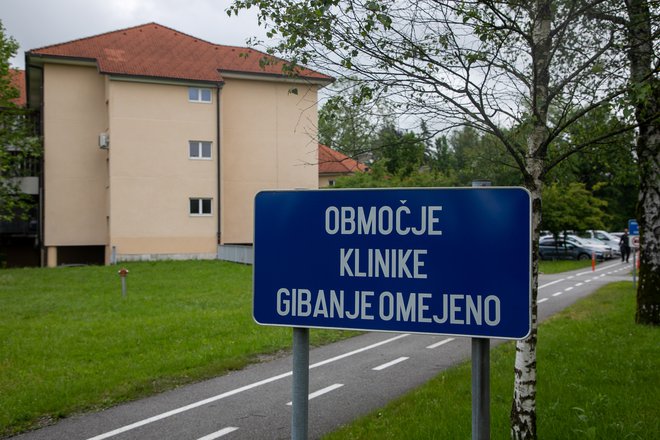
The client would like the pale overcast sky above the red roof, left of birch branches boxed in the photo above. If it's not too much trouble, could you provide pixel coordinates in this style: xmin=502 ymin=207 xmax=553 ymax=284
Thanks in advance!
xmin=0 ymin=0 xmax=265 ymax=68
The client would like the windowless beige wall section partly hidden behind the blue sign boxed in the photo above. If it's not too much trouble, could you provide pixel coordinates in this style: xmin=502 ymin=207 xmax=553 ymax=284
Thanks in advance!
xmin=220 ymin=78 xmax=318 ymax=244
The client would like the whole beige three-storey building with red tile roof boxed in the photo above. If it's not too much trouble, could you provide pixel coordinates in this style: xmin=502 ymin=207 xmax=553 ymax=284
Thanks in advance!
xmin=26 ymin=23 xmax=332 ymax=266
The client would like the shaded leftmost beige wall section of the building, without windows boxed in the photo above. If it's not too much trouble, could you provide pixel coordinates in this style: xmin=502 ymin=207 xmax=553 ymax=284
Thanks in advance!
xmin=43 ymin=64 xmax=108 ymax=251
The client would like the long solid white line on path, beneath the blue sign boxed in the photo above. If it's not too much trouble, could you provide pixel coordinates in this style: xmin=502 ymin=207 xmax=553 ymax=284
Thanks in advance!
xmin=87 ymin=333 xmax=409 ymax=440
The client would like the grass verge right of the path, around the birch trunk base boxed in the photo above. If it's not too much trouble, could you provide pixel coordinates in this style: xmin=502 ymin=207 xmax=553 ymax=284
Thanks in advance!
xmin=324 ymin=282 xmax=660 ymax=440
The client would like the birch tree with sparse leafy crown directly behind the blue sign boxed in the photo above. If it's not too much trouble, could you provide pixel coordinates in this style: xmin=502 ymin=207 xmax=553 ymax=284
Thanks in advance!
xmin=230 ymin=0 xmax=644 ymax=439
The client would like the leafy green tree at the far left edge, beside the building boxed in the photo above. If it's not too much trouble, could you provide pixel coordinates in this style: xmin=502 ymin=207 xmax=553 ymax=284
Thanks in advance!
xmin=0 ymin=21 xmax=39 ymax=221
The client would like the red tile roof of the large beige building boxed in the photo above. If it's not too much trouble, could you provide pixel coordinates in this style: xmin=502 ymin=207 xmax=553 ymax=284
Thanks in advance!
xmin=28 ymin=23 xmax=332 ymax=82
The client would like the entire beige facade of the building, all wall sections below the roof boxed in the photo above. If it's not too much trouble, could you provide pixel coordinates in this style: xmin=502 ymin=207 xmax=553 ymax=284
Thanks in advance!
xmin=43 ymin=64 xmax=319 ymax=265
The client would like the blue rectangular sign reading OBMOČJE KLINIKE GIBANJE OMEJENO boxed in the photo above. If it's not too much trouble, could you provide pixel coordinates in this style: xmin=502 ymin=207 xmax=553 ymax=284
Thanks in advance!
xmin=253 ymin=187 xmax=532 ymax=339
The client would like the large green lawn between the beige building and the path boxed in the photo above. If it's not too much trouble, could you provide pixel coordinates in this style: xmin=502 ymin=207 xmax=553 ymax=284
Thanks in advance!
xmin=0 ymin=261 xmax=356 ymax=436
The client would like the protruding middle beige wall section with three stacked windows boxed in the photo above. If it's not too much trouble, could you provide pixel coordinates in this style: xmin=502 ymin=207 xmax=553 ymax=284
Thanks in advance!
xmin=108 ymin=80 xmax=218 ymax=259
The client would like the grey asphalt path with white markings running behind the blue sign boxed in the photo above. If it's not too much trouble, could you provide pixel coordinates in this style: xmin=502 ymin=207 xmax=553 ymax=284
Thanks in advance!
xmin=14 ymin=260 xmax=631 ymax=440
